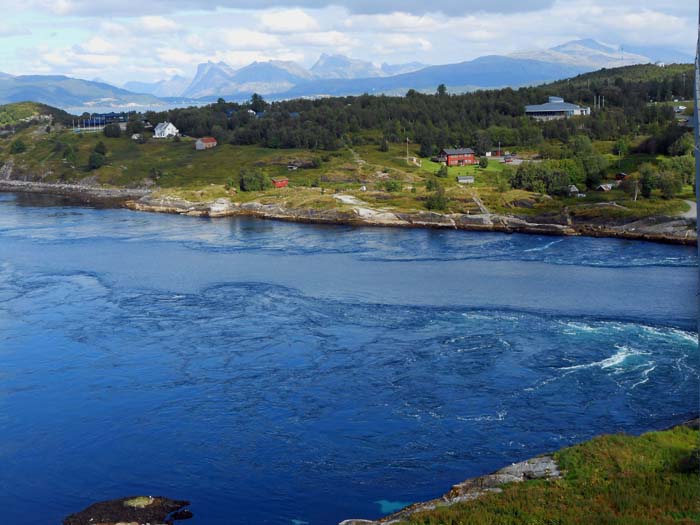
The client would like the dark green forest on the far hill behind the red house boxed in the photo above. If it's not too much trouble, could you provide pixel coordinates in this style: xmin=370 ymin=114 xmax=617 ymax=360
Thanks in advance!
xmin=139 ymin=64 xmax=693 ymax=156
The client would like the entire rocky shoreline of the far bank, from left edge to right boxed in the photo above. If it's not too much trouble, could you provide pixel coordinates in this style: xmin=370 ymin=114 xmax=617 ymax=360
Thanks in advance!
xmin=0 ymin=179 xmax=697 ymax=245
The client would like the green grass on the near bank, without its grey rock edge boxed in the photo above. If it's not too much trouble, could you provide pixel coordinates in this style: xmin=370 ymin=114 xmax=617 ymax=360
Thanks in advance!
xmin=406 ymin=428 xmax=700 ymax=525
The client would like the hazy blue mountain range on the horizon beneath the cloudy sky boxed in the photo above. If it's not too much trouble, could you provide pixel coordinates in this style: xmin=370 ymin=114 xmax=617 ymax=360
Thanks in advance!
xmin=0 ymin=39 xmax=692 ymax=109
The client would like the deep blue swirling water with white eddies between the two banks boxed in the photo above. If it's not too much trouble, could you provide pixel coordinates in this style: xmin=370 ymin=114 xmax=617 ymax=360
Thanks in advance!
xmin=0 ymin=195 xmax=700 ymax=525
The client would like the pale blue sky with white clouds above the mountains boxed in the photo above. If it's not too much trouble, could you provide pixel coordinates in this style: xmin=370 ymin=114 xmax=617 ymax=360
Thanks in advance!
xmin=0 ymin=0 xmax=697 ymax=85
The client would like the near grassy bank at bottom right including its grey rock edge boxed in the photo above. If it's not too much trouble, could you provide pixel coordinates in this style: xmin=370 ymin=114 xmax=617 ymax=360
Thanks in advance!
xmin=340 ymin=418 xmax=700 ymax=525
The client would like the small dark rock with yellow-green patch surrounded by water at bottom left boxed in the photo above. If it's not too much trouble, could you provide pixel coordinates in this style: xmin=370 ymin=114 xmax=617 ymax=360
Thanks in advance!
xmin=63 ymin=496 xmax=192 ymax=525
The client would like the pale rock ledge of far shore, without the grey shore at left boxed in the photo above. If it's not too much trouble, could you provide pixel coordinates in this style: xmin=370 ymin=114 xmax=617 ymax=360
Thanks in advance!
xmin=125 ymin=194 xmax=697 ymax=245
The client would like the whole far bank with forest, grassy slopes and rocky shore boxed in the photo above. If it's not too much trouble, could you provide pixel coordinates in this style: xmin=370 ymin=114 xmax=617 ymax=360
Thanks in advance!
xmin=0 ymin=64 xmax=697 ymax=244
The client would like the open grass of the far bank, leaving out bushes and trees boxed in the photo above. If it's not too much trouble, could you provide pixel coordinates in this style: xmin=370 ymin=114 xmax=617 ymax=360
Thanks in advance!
xmin=0 ymin=121 xmax=693 ymax=220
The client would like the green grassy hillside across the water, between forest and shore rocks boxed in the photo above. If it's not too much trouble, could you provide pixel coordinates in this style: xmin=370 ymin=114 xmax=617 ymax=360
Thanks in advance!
xmin=0 ymin=105 xmax=693 ymax=220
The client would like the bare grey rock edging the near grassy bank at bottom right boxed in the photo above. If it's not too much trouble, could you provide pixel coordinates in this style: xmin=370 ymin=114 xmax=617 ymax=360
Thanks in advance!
xmin=340 ymin=455 xmax=562 ymax=525
